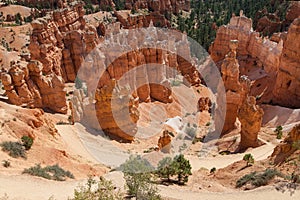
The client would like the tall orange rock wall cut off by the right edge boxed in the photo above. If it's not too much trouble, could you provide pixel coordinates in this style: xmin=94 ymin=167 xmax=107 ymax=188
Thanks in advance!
xmin=273 ymin=18 xmax=300 ymax=108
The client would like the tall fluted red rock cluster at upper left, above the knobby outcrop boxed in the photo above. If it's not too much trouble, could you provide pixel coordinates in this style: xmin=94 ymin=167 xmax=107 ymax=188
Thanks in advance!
xmin=28 ymin=1 xmax=98 ymax=81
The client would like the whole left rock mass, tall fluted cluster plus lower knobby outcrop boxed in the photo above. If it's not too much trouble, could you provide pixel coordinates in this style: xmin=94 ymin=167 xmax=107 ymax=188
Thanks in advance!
xmin=1 ymin=3 xmax=98 ymax=113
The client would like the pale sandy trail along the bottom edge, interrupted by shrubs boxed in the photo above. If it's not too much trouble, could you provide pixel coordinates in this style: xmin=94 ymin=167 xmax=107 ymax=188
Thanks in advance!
xmin=0 ymin=173 xmax=300 ymax=200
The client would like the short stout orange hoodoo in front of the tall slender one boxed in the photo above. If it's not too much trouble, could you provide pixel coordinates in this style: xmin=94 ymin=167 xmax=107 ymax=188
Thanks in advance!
xmin=238 ymin=96 xmax=264 ymax=151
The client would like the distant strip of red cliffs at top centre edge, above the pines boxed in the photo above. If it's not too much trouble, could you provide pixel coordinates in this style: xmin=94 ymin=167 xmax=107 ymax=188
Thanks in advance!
xmin=125 ymin=0 xmax=190 ymax=14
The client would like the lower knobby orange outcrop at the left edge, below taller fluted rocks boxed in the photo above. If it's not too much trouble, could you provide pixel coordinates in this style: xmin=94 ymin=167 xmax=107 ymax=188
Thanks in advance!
xmin=1 ymin=61 xmax=67 ymax=113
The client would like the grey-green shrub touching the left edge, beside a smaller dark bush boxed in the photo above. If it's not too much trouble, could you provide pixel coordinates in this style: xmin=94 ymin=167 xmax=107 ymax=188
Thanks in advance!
xmin=0 ymin=142 xmax=26 ymax=158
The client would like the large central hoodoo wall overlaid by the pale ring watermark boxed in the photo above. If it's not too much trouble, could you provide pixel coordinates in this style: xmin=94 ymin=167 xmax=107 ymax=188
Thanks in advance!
xmin=73 ymin=23 xmax=200 ymax=142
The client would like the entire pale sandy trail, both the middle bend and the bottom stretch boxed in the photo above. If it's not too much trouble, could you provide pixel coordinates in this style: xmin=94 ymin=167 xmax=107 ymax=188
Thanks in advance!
xmin=0 ymin=125 xmax=300 ymax=200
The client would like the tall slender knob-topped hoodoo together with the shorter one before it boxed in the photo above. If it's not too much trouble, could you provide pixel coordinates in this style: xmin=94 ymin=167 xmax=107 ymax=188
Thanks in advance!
xmin=221 ymin=40 xmax=263 ymax=150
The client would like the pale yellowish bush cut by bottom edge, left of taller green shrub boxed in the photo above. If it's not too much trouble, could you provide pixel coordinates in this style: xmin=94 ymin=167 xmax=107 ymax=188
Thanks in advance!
xmin=72 ymin=177 xmax=123 ymax=200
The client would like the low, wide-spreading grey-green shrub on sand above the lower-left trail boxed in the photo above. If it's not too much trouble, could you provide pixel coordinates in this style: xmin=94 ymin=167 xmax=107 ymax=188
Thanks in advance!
xmin=23 ymin=164 xmax=74 ymax=181
